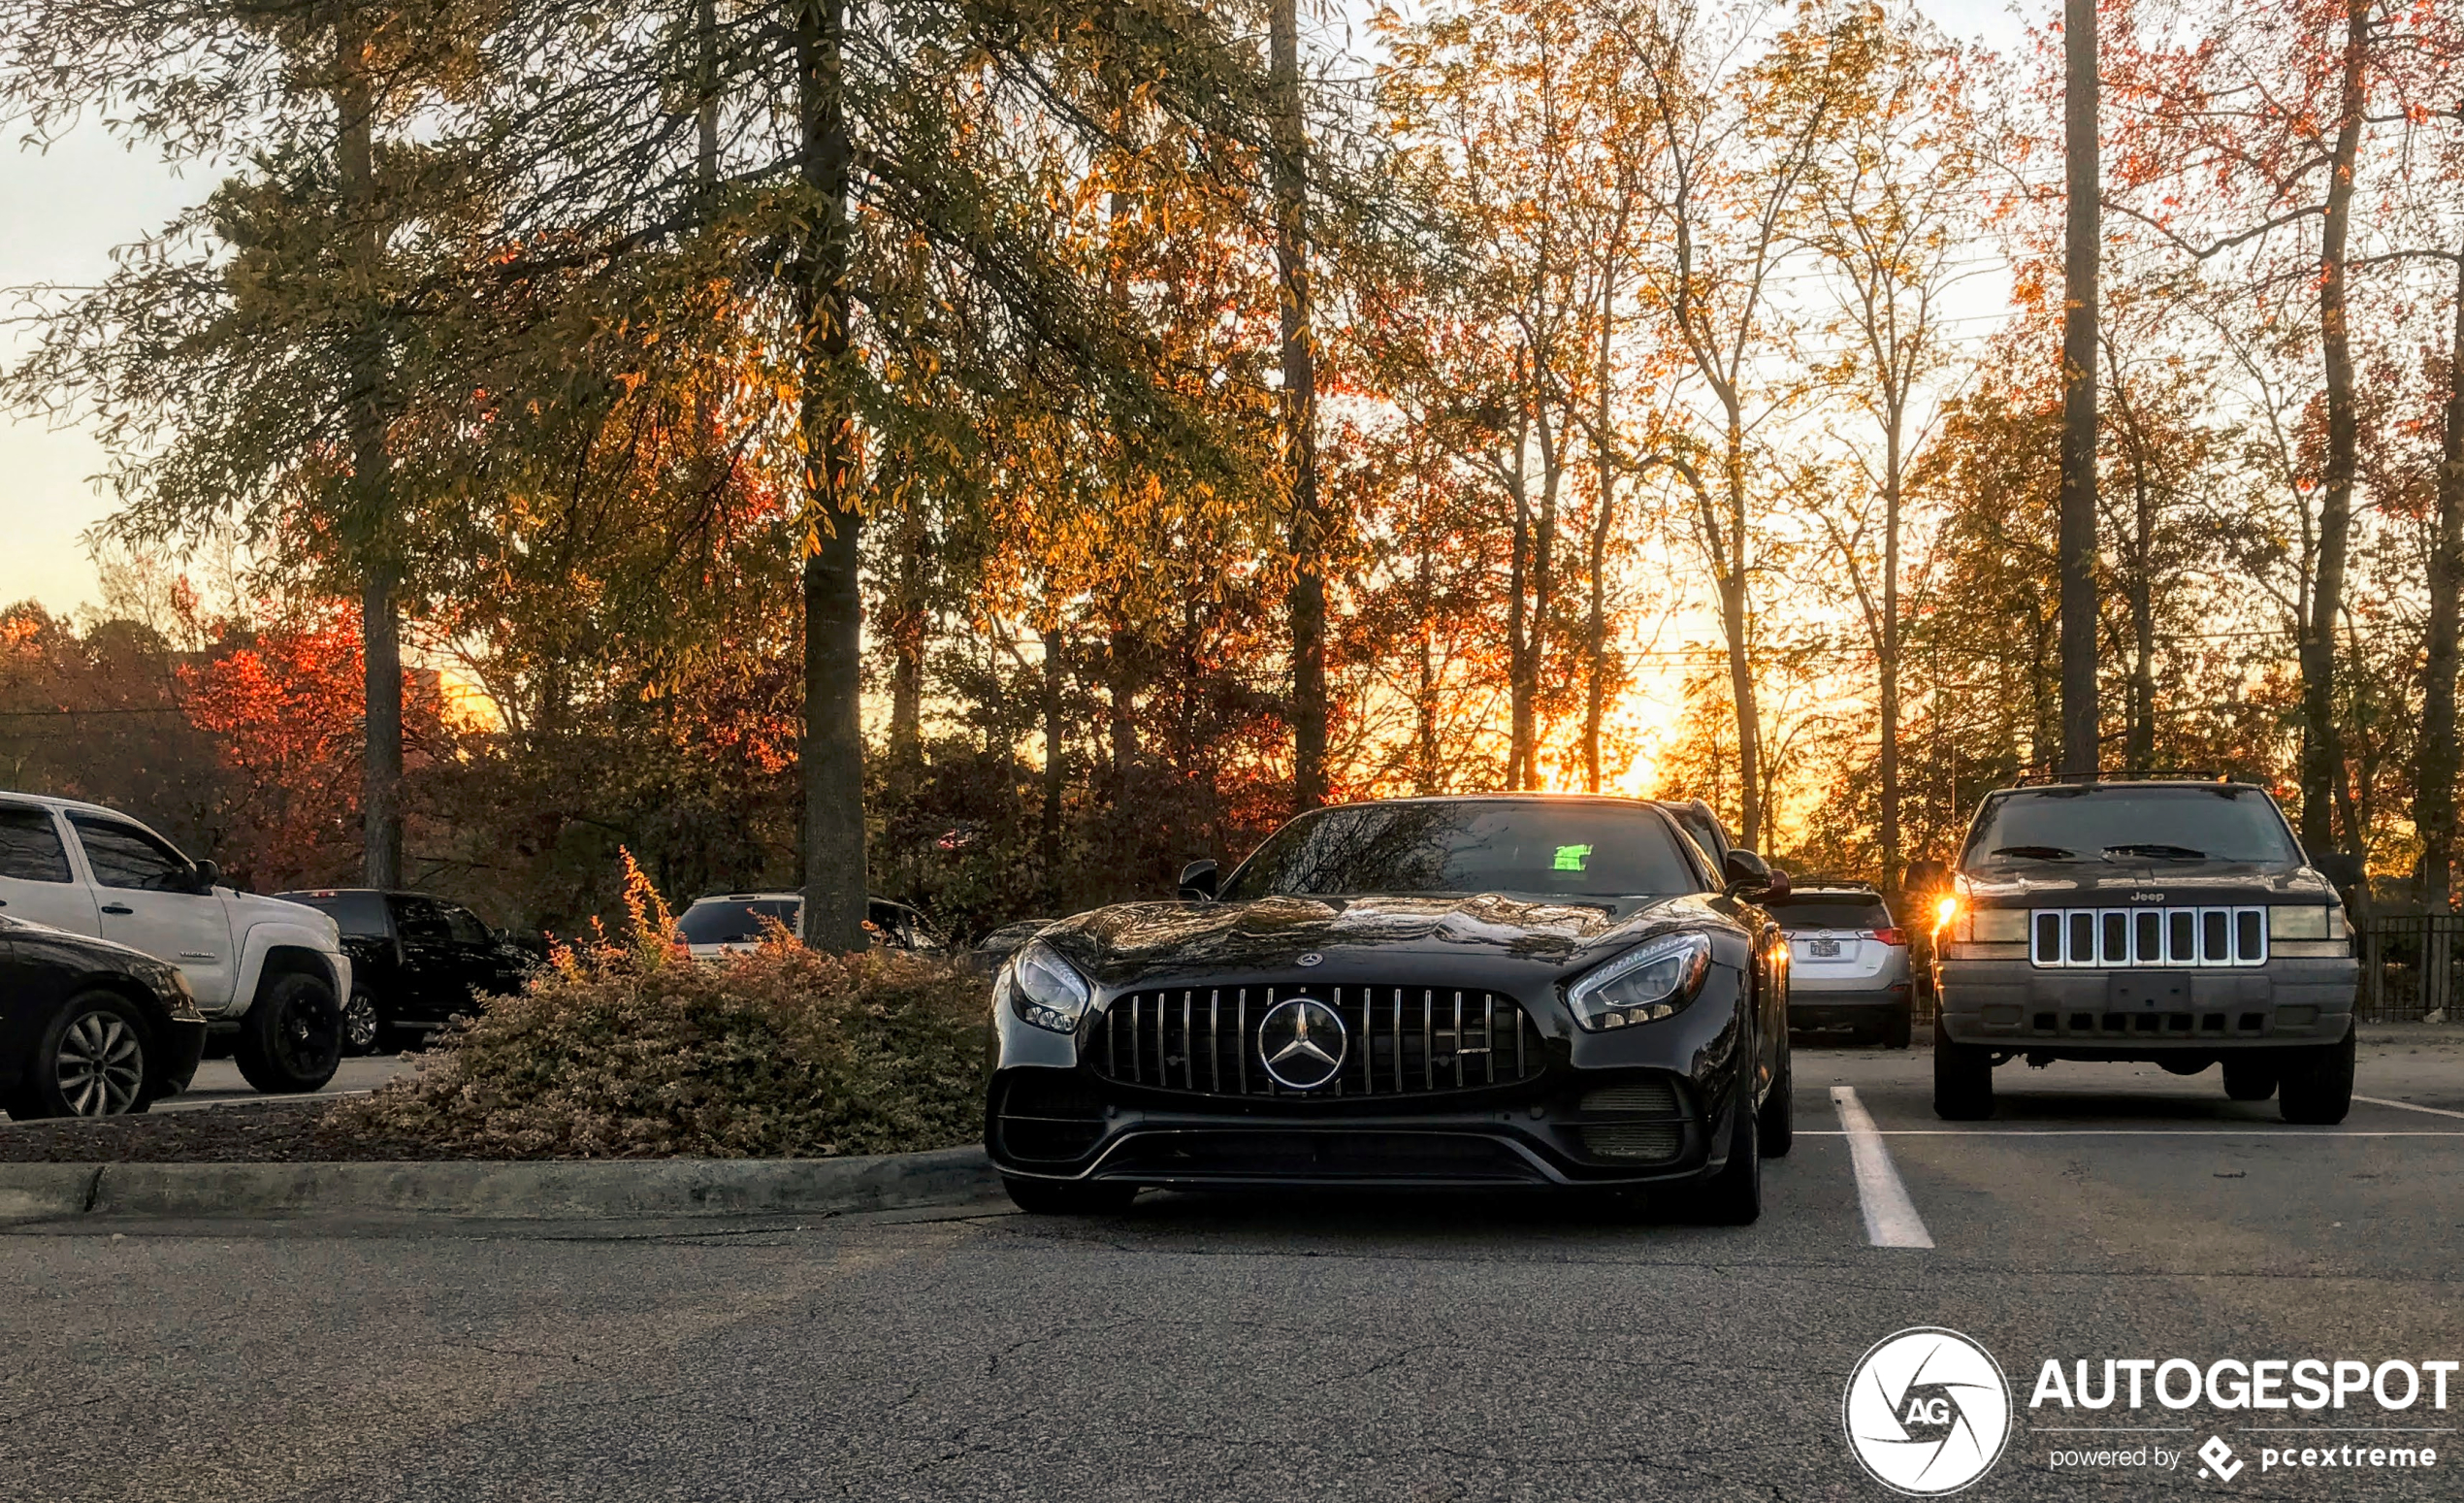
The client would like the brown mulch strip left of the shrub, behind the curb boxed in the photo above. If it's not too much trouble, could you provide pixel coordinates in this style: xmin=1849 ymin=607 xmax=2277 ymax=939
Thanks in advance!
xmin=0 ymin=1101 xmax=495 ymax=1163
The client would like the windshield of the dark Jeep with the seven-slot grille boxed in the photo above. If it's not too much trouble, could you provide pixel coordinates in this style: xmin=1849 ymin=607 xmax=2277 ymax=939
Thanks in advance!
xmin=1961 ymin=784 xmax=2299 ymax=869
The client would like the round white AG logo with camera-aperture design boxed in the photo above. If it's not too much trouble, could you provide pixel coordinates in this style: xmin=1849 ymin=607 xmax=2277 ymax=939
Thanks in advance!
xmin=1843 ymin=1325 xmax=2011 ymax=1498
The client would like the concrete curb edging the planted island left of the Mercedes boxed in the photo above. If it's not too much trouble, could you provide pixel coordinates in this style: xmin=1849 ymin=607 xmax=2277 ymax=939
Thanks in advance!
xmin=0 ymin=1146 xmax=1000 ymax=1220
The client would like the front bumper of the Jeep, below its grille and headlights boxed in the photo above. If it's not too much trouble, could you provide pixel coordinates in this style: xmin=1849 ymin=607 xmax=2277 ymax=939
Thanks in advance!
xmin=1934 ymin=959 xmax=2360 ymax=1060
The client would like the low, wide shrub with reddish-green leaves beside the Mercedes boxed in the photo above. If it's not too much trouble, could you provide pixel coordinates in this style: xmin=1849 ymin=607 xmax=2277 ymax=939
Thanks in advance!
xmin=323 ymin=852 xmax=989 ymax=1158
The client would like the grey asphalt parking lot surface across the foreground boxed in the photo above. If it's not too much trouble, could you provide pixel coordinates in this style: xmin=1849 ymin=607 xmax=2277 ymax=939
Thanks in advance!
xmin=0 ymin=1029 xmax=2464 ymax=1503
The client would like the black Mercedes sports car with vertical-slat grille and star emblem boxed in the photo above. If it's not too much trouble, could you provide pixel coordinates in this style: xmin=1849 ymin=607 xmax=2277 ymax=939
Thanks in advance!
xmin=986 ymin=796 xmax=1792 ymax=1223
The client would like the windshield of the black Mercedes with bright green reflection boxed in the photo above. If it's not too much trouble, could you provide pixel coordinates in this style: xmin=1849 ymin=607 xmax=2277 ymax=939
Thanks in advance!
xmin=1224 ymin=801 xmax=1702 ymax=899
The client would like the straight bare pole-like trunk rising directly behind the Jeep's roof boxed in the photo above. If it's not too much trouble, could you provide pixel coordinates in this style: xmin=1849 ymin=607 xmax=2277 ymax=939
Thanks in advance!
xmin=2055 ymin=0 xmax=2102 ymax=773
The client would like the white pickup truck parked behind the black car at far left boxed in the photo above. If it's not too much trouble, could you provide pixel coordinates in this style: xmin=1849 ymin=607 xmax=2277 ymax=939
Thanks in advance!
xmin=0 ymin=791 xmax=350 ymax=1092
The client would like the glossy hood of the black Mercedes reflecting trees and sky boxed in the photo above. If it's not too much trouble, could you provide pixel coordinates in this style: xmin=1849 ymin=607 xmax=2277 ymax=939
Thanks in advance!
xmin=1042 ymin=892 xmax=1730 ymax=988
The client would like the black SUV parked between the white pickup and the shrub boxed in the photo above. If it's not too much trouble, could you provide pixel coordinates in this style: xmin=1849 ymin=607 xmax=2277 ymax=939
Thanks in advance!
xmin=276 ymin=887 xmax=544 ymax=1055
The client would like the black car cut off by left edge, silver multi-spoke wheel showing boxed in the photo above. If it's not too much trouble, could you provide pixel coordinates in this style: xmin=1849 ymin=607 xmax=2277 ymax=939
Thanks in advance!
xmin=0 ymin=914 xmax=205 ymax=1121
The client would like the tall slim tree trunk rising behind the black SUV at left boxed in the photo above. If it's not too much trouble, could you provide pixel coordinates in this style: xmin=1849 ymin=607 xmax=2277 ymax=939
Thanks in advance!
xmin=335 ymin=5 xmax=402 ymax=887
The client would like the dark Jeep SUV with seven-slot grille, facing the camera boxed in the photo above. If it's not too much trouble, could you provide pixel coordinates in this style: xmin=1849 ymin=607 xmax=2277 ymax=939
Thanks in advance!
xmin=1934 ymin=776 xmax=2360 ymax=1124
